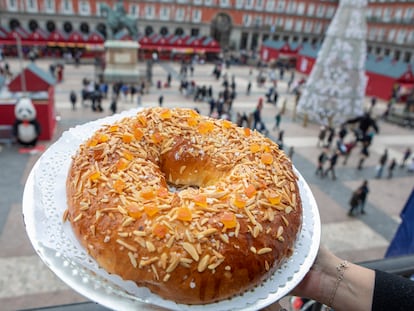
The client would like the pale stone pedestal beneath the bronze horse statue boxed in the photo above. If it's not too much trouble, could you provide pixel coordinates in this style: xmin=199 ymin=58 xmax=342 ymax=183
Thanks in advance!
xmin=103 ymin=40 xmax=142 ymax=83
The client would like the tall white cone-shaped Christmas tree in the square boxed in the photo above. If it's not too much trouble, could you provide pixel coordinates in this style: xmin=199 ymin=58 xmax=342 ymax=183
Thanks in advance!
xmin=298 ymin=0 xmax=367 ymax=126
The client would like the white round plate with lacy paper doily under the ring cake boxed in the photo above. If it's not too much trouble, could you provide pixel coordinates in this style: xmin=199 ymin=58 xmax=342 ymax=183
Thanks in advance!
xmin=23 ymin=109 xmax=321 ymax=311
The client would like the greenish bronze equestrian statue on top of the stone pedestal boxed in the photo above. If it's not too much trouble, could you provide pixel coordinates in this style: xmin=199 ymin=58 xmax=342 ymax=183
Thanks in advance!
xmin=100 ymin=0 xmax=138 ymax=40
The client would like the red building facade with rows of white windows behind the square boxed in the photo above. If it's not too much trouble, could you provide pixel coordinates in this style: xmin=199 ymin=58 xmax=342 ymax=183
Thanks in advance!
xmin=0 ymin=0 xmax=414 ymax=62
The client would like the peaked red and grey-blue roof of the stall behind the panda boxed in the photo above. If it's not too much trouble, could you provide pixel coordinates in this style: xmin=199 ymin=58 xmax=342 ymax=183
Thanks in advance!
xmin=8 ymin=63 xmax=55 ymax=92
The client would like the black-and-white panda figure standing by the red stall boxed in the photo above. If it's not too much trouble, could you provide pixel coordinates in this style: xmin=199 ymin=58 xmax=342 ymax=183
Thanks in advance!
xmin=13 ymin=98 xmax=41 ymax=147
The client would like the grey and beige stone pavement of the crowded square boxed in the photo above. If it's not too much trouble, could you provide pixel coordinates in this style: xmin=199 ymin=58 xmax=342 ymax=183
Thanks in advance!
xmin=0 ymin=60 xmax=414 ymax=310
